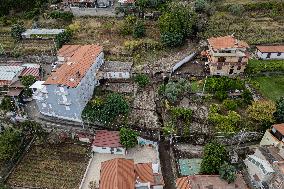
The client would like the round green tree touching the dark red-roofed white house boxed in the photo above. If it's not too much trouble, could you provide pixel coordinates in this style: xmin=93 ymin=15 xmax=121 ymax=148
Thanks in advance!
xmin=119 ymin=127 xmax=138 ymax=148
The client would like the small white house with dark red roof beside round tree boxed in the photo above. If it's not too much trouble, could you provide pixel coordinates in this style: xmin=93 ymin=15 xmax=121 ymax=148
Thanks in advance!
xmin=92 ymin=130 xmax=126 ymax=155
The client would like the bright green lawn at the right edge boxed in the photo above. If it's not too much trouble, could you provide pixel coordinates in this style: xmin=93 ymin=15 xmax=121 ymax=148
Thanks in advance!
xmin=252 ymin=76 xmax=284 ymax=101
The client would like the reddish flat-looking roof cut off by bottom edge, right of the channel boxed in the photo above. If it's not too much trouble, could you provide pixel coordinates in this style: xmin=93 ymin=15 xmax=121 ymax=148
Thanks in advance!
xmin=176 ymin=175 xmax=248 ymax=189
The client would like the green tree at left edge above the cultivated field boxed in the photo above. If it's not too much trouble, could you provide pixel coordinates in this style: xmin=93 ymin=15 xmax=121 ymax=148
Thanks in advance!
xmin=0 ymin=129 xmax=21 ymax=160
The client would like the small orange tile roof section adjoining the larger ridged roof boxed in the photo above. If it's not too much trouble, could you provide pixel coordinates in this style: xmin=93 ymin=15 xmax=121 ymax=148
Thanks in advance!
xmin=134 ymin=163 xmax=155 ymax=185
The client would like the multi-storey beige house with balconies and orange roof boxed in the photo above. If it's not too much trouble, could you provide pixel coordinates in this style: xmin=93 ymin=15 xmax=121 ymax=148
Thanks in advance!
xmin=205 ymin=36 xmax=249 ymax=76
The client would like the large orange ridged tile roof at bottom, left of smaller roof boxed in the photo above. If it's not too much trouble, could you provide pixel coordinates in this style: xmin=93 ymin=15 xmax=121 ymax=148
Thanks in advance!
xmin=99 ymin=158 xmax=135 ymax=189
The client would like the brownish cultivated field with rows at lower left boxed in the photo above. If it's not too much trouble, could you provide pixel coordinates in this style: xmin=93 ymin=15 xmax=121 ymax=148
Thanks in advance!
xmin=8 ymin=143 xmax=89 ymax=189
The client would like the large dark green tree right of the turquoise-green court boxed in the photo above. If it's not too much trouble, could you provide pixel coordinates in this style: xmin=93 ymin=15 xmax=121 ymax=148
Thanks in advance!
xmin=201 ymin=141 xmax=228 ymax=174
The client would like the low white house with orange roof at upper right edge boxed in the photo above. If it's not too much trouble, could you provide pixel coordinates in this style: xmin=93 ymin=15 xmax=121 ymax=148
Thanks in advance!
xmin=256 ymin=45 xmax=284 ymax=60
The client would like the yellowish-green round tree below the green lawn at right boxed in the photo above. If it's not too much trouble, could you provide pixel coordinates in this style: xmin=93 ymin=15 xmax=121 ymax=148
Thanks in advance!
xmin=247 ymin=100 xmax=276 ymax=125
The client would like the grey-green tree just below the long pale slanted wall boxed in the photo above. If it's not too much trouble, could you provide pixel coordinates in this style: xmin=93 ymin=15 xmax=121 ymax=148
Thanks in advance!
xmin=159 ymin=78 xmax=190 ymax=103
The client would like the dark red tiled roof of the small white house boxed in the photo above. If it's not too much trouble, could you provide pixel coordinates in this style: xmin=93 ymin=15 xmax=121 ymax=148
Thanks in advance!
xmin=93 ymin=130 xmax=123 ymax=148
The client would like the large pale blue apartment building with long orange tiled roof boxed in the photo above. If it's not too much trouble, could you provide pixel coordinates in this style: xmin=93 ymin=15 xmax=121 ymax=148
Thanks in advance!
xmin=34 ymin=45 xmax=104 ymax=122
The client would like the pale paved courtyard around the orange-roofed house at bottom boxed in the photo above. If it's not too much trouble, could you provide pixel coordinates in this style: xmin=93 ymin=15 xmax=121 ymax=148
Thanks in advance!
xmin=80 ymin=146 xmax=159 ymax=189
